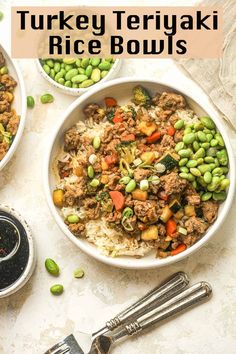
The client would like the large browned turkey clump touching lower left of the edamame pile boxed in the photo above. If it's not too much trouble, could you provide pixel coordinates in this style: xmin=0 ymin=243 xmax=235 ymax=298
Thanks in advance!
xmin=160 ymin=172 xmax=188 ymax=195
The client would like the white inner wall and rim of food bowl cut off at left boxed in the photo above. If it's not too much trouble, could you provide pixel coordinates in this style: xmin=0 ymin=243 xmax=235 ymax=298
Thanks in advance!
xmin=0 ymin=45 xmax=26 ymax=170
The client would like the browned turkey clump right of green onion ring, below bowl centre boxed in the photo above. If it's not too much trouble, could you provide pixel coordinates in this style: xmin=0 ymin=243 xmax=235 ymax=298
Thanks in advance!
xmin=134 ymin=200 xmax=158 ymax=223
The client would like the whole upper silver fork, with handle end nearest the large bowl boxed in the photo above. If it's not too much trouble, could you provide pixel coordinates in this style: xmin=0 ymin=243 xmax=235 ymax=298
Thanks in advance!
xmin=45 ymin=272 xmax=189 ymax=354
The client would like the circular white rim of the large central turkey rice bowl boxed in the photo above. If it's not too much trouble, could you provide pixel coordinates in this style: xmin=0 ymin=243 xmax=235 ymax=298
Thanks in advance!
xmin=43 ymin=77 xmax=236 ymax=269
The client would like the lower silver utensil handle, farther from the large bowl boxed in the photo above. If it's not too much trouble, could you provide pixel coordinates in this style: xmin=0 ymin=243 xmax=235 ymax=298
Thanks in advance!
xmin=110 ymin=282 xmax=212 ymax=342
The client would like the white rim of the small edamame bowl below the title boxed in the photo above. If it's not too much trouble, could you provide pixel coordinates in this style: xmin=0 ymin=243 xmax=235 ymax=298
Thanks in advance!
xmin=35 ymin=59 xmax=122 ymax=96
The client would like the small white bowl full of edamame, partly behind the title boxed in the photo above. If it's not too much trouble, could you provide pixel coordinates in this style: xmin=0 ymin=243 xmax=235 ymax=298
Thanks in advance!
xmin=36 ymin=58 xmax=121 ymax=96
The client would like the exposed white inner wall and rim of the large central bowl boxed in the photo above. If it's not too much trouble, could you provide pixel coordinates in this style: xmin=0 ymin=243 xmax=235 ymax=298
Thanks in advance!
xmin=45 ymin=78 xmax=235 ymax=268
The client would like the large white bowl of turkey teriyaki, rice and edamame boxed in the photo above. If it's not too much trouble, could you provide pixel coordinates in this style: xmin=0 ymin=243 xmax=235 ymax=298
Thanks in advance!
xmin=44 ymin=78 xmax=235 ymax=269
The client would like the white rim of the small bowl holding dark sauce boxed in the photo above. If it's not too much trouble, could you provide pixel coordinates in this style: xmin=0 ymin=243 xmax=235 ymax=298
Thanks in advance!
xmin=0 ymin=204 xmax=36 ymax=298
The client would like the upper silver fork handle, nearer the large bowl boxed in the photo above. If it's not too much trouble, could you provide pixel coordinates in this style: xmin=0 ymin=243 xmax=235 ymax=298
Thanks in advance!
xmin=93 ymin=272 xmax=189 ymax=337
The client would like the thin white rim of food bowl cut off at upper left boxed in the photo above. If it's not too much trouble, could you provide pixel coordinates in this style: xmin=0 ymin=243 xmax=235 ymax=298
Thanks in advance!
xmin=0 ymin=44 xmax=26 ymax=170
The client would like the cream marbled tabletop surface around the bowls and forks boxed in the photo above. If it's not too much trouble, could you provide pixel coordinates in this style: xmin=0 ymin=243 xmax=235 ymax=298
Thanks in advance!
xmin=0 ymin=0 xmax=236 ymax=354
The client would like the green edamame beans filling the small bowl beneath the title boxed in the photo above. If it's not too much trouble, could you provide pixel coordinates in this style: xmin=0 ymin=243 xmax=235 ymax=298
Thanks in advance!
xmin=40 ymin=58 xmax=115 ymax=88
